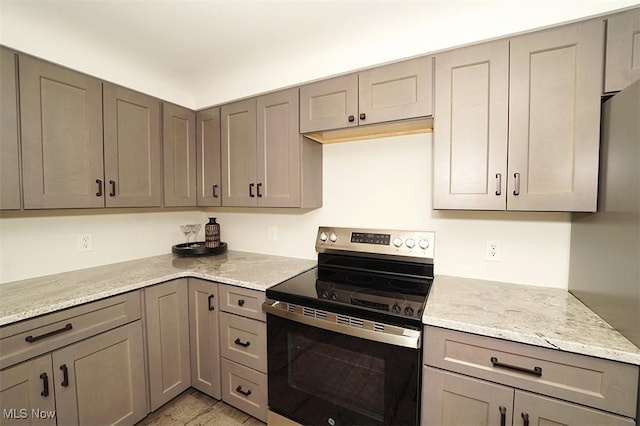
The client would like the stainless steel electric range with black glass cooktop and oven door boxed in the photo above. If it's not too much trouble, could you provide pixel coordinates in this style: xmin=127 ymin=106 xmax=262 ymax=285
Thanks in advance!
xmin=263 ymin=227 xmax=435 ymax=426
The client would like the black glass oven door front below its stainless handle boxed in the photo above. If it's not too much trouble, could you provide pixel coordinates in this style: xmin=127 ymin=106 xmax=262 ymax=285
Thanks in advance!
xmin=267 ymin=304 xmax=421 ymax=426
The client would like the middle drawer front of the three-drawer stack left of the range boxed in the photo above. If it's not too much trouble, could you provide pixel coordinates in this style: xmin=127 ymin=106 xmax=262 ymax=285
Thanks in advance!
xmin=220 ymin=312 xmax=267 ymax=373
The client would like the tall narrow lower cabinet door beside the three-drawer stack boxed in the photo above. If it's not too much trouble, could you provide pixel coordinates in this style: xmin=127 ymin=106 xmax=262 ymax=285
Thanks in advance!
xmin=189 ymin=278 xmax=222 ymax=399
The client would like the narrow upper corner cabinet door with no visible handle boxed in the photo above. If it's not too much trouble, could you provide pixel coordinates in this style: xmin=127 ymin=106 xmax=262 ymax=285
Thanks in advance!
xmin=162 ymin=103 xmax=197 ymax=207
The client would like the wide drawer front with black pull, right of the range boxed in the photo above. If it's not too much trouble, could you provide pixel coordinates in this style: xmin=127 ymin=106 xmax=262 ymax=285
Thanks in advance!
xmin=424 ymin=327 xmax=638 ymax=417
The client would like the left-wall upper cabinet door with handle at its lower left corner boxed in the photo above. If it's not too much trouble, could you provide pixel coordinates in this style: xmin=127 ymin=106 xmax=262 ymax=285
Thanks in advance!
xmin=104 ymin=83 xmax=162 ymax=207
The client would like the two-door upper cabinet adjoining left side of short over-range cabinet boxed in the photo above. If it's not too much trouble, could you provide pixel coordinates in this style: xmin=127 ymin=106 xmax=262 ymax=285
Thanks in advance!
xmin=222 ymin=89 xmax=322 ymax=208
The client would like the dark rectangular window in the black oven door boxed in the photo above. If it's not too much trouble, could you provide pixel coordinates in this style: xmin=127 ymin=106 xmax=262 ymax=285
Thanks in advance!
xmin=288 ymin=333 xmax=385 ymax=422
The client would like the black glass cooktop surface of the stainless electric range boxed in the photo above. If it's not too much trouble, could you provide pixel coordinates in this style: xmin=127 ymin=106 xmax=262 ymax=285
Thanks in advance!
xmin=266 ymin=255 xmax=433 ymax=325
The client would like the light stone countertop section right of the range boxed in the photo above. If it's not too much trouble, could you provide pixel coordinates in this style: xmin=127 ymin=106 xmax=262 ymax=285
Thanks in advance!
xmin=422 ymin=275 xmax=640 ymax=365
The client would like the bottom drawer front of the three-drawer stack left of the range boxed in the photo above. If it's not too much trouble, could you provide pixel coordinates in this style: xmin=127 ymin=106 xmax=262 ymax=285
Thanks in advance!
xmin=221 ymin=358 xmax=267 ymax=422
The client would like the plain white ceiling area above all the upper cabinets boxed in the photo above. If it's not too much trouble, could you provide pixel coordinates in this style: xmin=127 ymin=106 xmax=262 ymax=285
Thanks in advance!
xmin=0 ymin=0 xmax=640 ymax=108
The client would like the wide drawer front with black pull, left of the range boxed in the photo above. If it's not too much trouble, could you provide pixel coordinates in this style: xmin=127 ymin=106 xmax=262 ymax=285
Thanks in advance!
xmin=0 ymin=291 xmax=140 ymax=369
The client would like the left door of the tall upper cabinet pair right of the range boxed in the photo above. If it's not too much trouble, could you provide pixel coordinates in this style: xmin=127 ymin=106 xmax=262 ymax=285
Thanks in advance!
xmin=433 ymin=40 xmax=509 ymax=210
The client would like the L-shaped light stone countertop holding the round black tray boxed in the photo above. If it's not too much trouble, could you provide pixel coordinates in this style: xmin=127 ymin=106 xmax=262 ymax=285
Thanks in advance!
xmin=0 ymin=251 xmax=317 ymax=326
